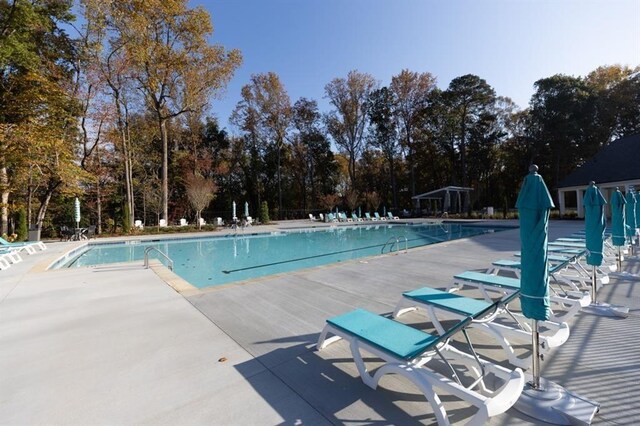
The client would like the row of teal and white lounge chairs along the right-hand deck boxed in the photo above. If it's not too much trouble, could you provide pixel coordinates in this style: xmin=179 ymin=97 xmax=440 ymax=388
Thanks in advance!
xmin=317 ymin=230 xmax=615 ymax=424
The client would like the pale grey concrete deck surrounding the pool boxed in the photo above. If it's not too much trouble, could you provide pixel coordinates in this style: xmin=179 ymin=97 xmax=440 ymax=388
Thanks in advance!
xmin=0 ymin=221 xmax=640 ymax=425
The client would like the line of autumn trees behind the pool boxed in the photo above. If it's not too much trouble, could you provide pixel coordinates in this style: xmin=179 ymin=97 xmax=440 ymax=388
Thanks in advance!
xmin=0 ymin=0 xmax=640 ymax=238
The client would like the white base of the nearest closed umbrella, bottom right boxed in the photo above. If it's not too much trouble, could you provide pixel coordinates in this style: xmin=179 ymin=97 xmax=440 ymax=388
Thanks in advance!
xmin=513 ymin=374 xmax=600 ymax=425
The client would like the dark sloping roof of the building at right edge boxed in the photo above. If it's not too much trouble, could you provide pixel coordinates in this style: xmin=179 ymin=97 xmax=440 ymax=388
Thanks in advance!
xmin=558 ymin=133 xmax=640 ymax=188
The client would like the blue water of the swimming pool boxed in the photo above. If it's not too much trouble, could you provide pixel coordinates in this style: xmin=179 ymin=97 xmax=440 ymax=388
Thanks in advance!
xmin=62 ymin=224 xmax=508 ymax=288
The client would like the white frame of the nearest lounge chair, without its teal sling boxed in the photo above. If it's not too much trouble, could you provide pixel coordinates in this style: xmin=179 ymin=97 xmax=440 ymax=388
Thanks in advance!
xmin=316 ymin=310 xmax=525 ymax=426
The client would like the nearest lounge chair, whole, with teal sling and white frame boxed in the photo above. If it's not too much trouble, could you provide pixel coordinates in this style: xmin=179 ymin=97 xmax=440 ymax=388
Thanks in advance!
xmin=317 ymin=309 xmax=525 ymax=425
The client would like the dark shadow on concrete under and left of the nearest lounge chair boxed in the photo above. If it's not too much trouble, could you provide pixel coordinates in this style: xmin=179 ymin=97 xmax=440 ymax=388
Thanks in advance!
xmin=235 ymin=333 xmax=531 ymax=425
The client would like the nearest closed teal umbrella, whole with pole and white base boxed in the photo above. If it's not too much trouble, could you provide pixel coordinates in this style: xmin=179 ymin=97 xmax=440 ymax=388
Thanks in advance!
xmin=514 ymin=165 xmax=598 ymax=424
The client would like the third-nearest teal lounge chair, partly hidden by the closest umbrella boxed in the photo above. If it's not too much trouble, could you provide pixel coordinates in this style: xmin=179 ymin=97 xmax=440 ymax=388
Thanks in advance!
xmin=447 ymin=271 xmax=582 ymax=324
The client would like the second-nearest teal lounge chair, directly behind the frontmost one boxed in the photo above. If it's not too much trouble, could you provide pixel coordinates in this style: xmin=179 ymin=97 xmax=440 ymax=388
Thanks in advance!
xmin=393 ymin=287 xmax=569 ymax=369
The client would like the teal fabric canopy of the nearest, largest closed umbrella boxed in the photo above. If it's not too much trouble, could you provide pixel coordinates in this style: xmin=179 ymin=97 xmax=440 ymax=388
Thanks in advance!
xmin=516 ymin=166 xmax=554 ymax=321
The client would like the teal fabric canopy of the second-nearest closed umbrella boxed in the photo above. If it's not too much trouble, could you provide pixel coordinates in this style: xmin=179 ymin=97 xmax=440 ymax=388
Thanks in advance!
xmin=583 ymin=182 xmax=607 ymax=266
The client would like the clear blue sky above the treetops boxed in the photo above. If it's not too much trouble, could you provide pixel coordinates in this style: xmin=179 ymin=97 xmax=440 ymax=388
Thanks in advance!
xmin=198 ymin=0 xmax=640 ymax=133
